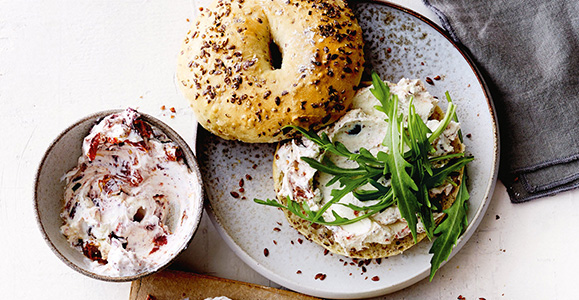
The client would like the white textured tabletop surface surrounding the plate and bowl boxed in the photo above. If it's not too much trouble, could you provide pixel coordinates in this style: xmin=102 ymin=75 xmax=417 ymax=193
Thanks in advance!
xmin=0 ymin=0 xmax=579 ymax=300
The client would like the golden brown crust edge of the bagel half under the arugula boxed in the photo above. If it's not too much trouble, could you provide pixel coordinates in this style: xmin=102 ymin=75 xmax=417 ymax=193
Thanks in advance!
xmin=273 ymin=99 xmax=464 ymax=259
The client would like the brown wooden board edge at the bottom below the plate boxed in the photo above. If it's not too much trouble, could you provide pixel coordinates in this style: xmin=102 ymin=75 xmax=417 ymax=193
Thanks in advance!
xmin=130 ymin=270 xmax=318 ymax=300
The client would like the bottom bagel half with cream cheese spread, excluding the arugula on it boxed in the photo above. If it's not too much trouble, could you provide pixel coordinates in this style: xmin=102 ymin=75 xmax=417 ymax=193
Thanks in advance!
xmin=273 ymin=79 xmax=464 ymax=259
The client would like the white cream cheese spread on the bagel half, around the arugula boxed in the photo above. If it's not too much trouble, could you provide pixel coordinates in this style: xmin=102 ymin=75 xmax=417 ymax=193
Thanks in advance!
xmin=274 ymin=79 xmax=460 ymax=251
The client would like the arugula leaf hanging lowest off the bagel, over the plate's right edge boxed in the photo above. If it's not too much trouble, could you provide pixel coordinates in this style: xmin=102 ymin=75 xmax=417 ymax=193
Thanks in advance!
xmin=428 ymin=174 xmax=470 ymax=281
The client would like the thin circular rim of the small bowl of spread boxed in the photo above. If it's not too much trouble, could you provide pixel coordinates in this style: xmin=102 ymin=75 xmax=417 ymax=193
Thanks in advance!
xmin=33 ymin=109 xmax=206 ymax=282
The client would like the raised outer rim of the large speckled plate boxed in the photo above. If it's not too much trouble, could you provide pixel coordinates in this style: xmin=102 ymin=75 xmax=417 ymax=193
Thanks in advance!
xmin=196 ymin=0 xmax=500 ymax=299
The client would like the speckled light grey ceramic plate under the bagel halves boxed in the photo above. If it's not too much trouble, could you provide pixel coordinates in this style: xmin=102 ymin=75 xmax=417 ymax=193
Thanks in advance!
xmin=197 ymin=3 xmax=498 ymax=298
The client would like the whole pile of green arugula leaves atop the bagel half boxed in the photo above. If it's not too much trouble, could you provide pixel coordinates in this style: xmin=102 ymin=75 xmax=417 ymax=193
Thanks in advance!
xmin=254 ymin=73 xmax=474 ymax=280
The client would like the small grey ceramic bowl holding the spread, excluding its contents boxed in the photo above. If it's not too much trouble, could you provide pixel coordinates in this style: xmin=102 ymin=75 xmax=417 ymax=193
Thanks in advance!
xmin=34 ymin=110 xmax=205 ymax=281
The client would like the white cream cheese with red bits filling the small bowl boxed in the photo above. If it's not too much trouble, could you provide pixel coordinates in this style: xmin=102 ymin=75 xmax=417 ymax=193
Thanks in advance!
xmin=61 ymin=109 xmax=201 ymax=276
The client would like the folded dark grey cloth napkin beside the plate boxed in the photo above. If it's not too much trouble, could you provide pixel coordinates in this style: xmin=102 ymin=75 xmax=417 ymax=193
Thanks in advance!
xmin=423 ymin=0 xmax=579 ymax=202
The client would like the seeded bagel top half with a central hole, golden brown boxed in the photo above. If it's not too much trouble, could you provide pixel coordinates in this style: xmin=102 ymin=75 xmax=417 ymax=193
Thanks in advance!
xmin=177 ymin=0 xmax=364 ymax=143
